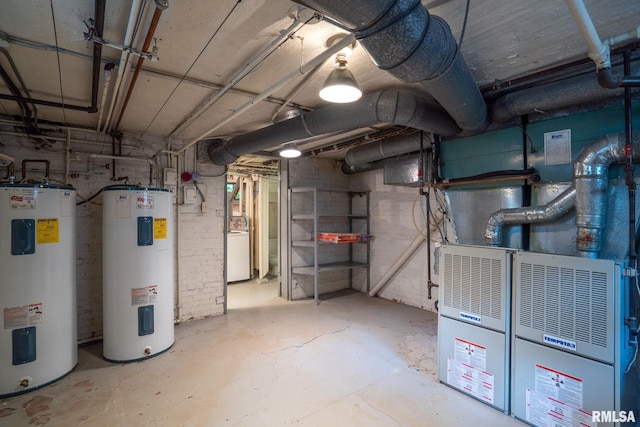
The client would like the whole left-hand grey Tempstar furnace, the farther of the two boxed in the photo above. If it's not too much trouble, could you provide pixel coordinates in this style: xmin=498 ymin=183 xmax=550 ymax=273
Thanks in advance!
xmin=438 ymin=245 xmax=513 ymax=413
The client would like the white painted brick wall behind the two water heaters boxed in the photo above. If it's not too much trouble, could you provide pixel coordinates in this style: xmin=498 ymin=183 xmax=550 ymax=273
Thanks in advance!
xmin=0 ymin=136 xmax=226 ymax=341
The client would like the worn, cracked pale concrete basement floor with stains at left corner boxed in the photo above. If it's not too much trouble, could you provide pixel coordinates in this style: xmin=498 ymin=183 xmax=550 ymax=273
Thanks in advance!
xmin=0 ymin=282 xmax=525 ymax=427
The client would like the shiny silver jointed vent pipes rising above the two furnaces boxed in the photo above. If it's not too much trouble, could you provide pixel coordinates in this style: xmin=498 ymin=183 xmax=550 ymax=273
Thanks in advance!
xmin=485 ymin=132 xmax=640 ymax=258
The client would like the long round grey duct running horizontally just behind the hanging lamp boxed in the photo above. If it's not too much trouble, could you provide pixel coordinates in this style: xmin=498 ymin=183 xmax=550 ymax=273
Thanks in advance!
xmin=209 ymin=90 xmax=460 ymax=166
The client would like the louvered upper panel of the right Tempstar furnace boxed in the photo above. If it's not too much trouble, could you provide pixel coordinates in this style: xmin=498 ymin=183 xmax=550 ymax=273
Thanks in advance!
xmin=514 ymin=252 xmax=615 ymax=362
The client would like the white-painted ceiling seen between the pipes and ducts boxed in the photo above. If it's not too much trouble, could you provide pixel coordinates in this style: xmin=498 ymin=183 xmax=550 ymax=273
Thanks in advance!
xmin=0 ymin=0 xmax=640 ymax=165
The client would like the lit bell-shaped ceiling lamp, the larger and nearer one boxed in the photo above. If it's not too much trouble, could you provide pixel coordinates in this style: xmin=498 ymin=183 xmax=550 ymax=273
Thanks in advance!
xmin=320 ymin=35 xmax=362 ymax=103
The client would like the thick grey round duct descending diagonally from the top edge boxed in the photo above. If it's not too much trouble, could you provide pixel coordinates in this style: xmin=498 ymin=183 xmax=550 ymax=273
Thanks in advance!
xmin=294 ymin=0 xmax=487 ymax=131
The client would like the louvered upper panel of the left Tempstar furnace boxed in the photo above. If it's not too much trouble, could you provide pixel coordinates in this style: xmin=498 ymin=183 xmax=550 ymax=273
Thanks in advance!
xmin=440 ymin=245 xmax=511 ymax=332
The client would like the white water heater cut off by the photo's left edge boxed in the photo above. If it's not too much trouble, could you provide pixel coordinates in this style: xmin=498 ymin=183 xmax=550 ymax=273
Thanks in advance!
xmin=0 ymin=183 xmax=78 ymax=397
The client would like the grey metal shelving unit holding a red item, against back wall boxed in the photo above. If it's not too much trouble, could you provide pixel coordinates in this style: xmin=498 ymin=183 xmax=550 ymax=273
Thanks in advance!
xmin=289 ymin=187 xmax=370 ymax=304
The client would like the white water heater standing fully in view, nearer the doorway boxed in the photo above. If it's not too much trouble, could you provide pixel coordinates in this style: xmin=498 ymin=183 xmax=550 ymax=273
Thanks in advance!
xmin=102 ymin=186 xmax=174 ymax=362
